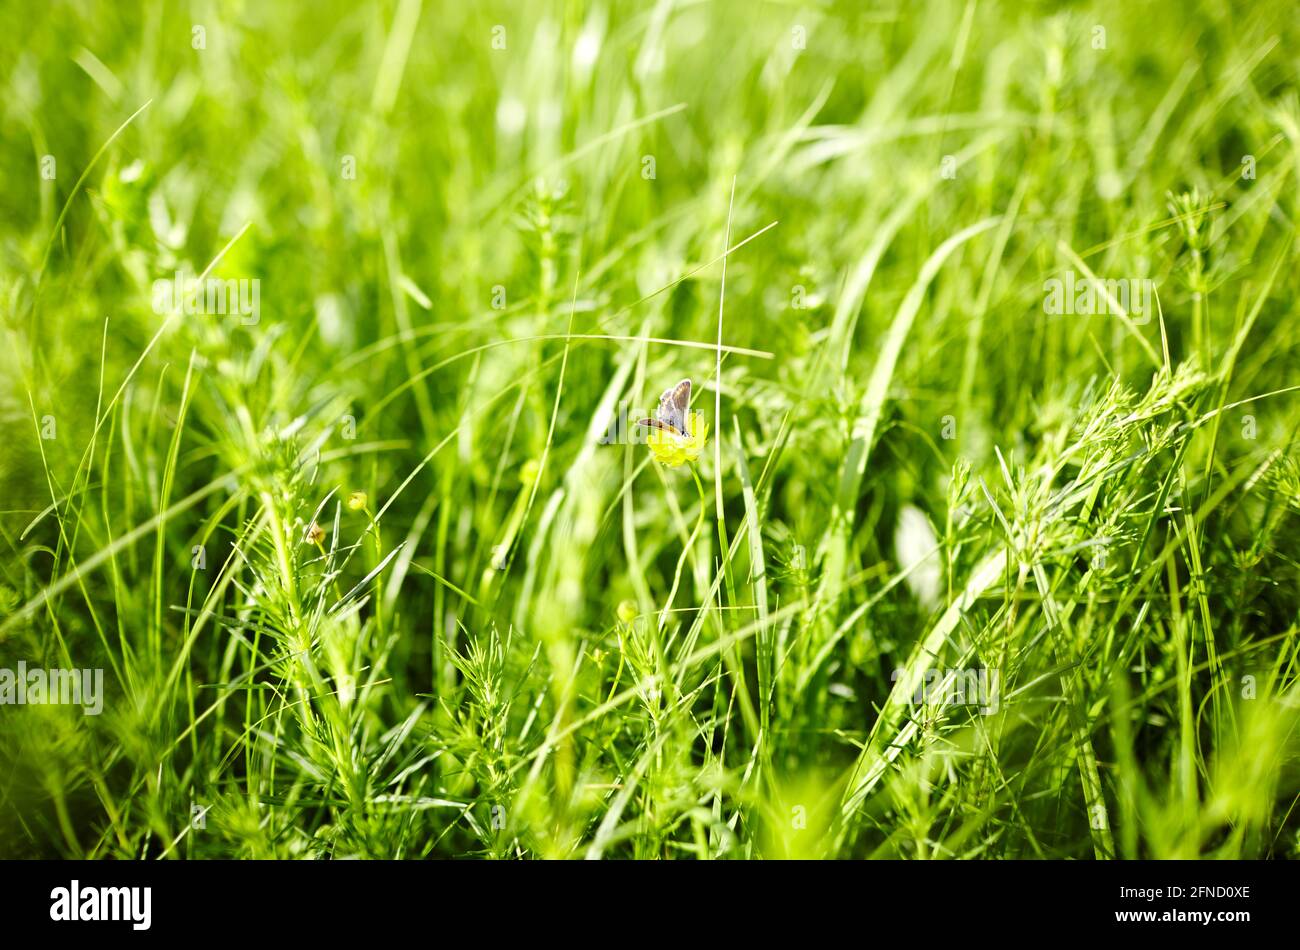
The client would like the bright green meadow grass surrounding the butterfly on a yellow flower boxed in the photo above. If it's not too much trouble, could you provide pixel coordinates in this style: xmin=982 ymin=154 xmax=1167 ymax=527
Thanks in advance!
xmin=0 ymin=0 xmax=1300 ymax=859
